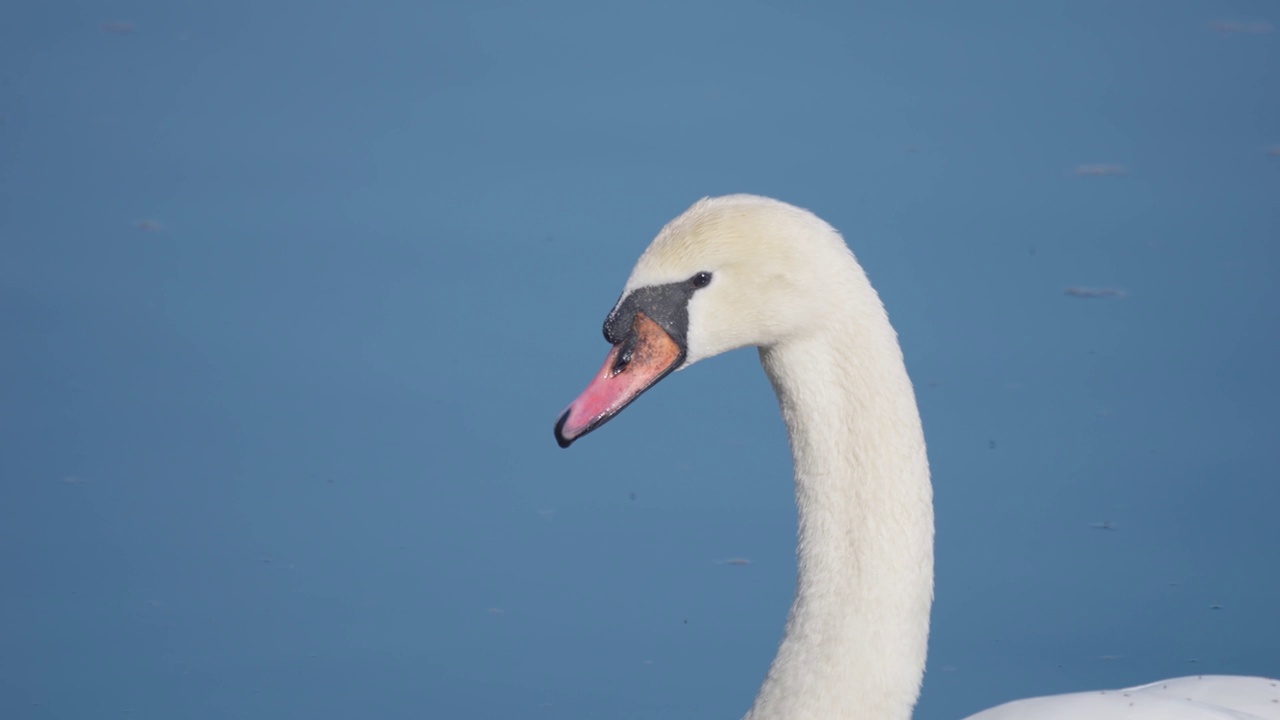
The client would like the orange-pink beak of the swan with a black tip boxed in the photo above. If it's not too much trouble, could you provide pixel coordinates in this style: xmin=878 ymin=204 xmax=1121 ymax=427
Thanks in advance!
xmin=556 ymin=313 xmax=685 ymax=447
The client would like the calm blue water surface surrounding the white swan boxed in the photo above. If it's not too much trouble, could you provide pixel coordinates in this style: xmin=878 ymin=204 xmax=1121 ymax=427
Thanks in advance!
xmin=0 ymin=0 xmax=1280 ymax=720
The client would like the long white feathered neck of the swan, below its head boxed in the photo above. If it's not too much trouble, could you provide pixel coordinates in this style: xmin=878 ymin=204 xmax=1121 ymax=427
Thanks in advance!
xmin=746 ymin=293 xmax=933 ymax=720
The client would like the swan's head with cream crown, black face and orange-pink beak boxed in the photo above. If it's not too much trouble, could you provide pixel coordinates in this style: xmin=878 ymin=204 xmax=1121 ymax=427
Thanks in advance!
xmin=556 ymin=195 xmax=869 ymax=447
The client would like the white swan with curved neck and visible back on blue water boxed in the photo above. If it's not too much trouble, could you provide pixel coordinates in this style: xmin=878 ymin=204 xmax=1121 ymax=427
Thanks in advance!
xmin=556 ymin=195 xmax=1280 ymax=720
